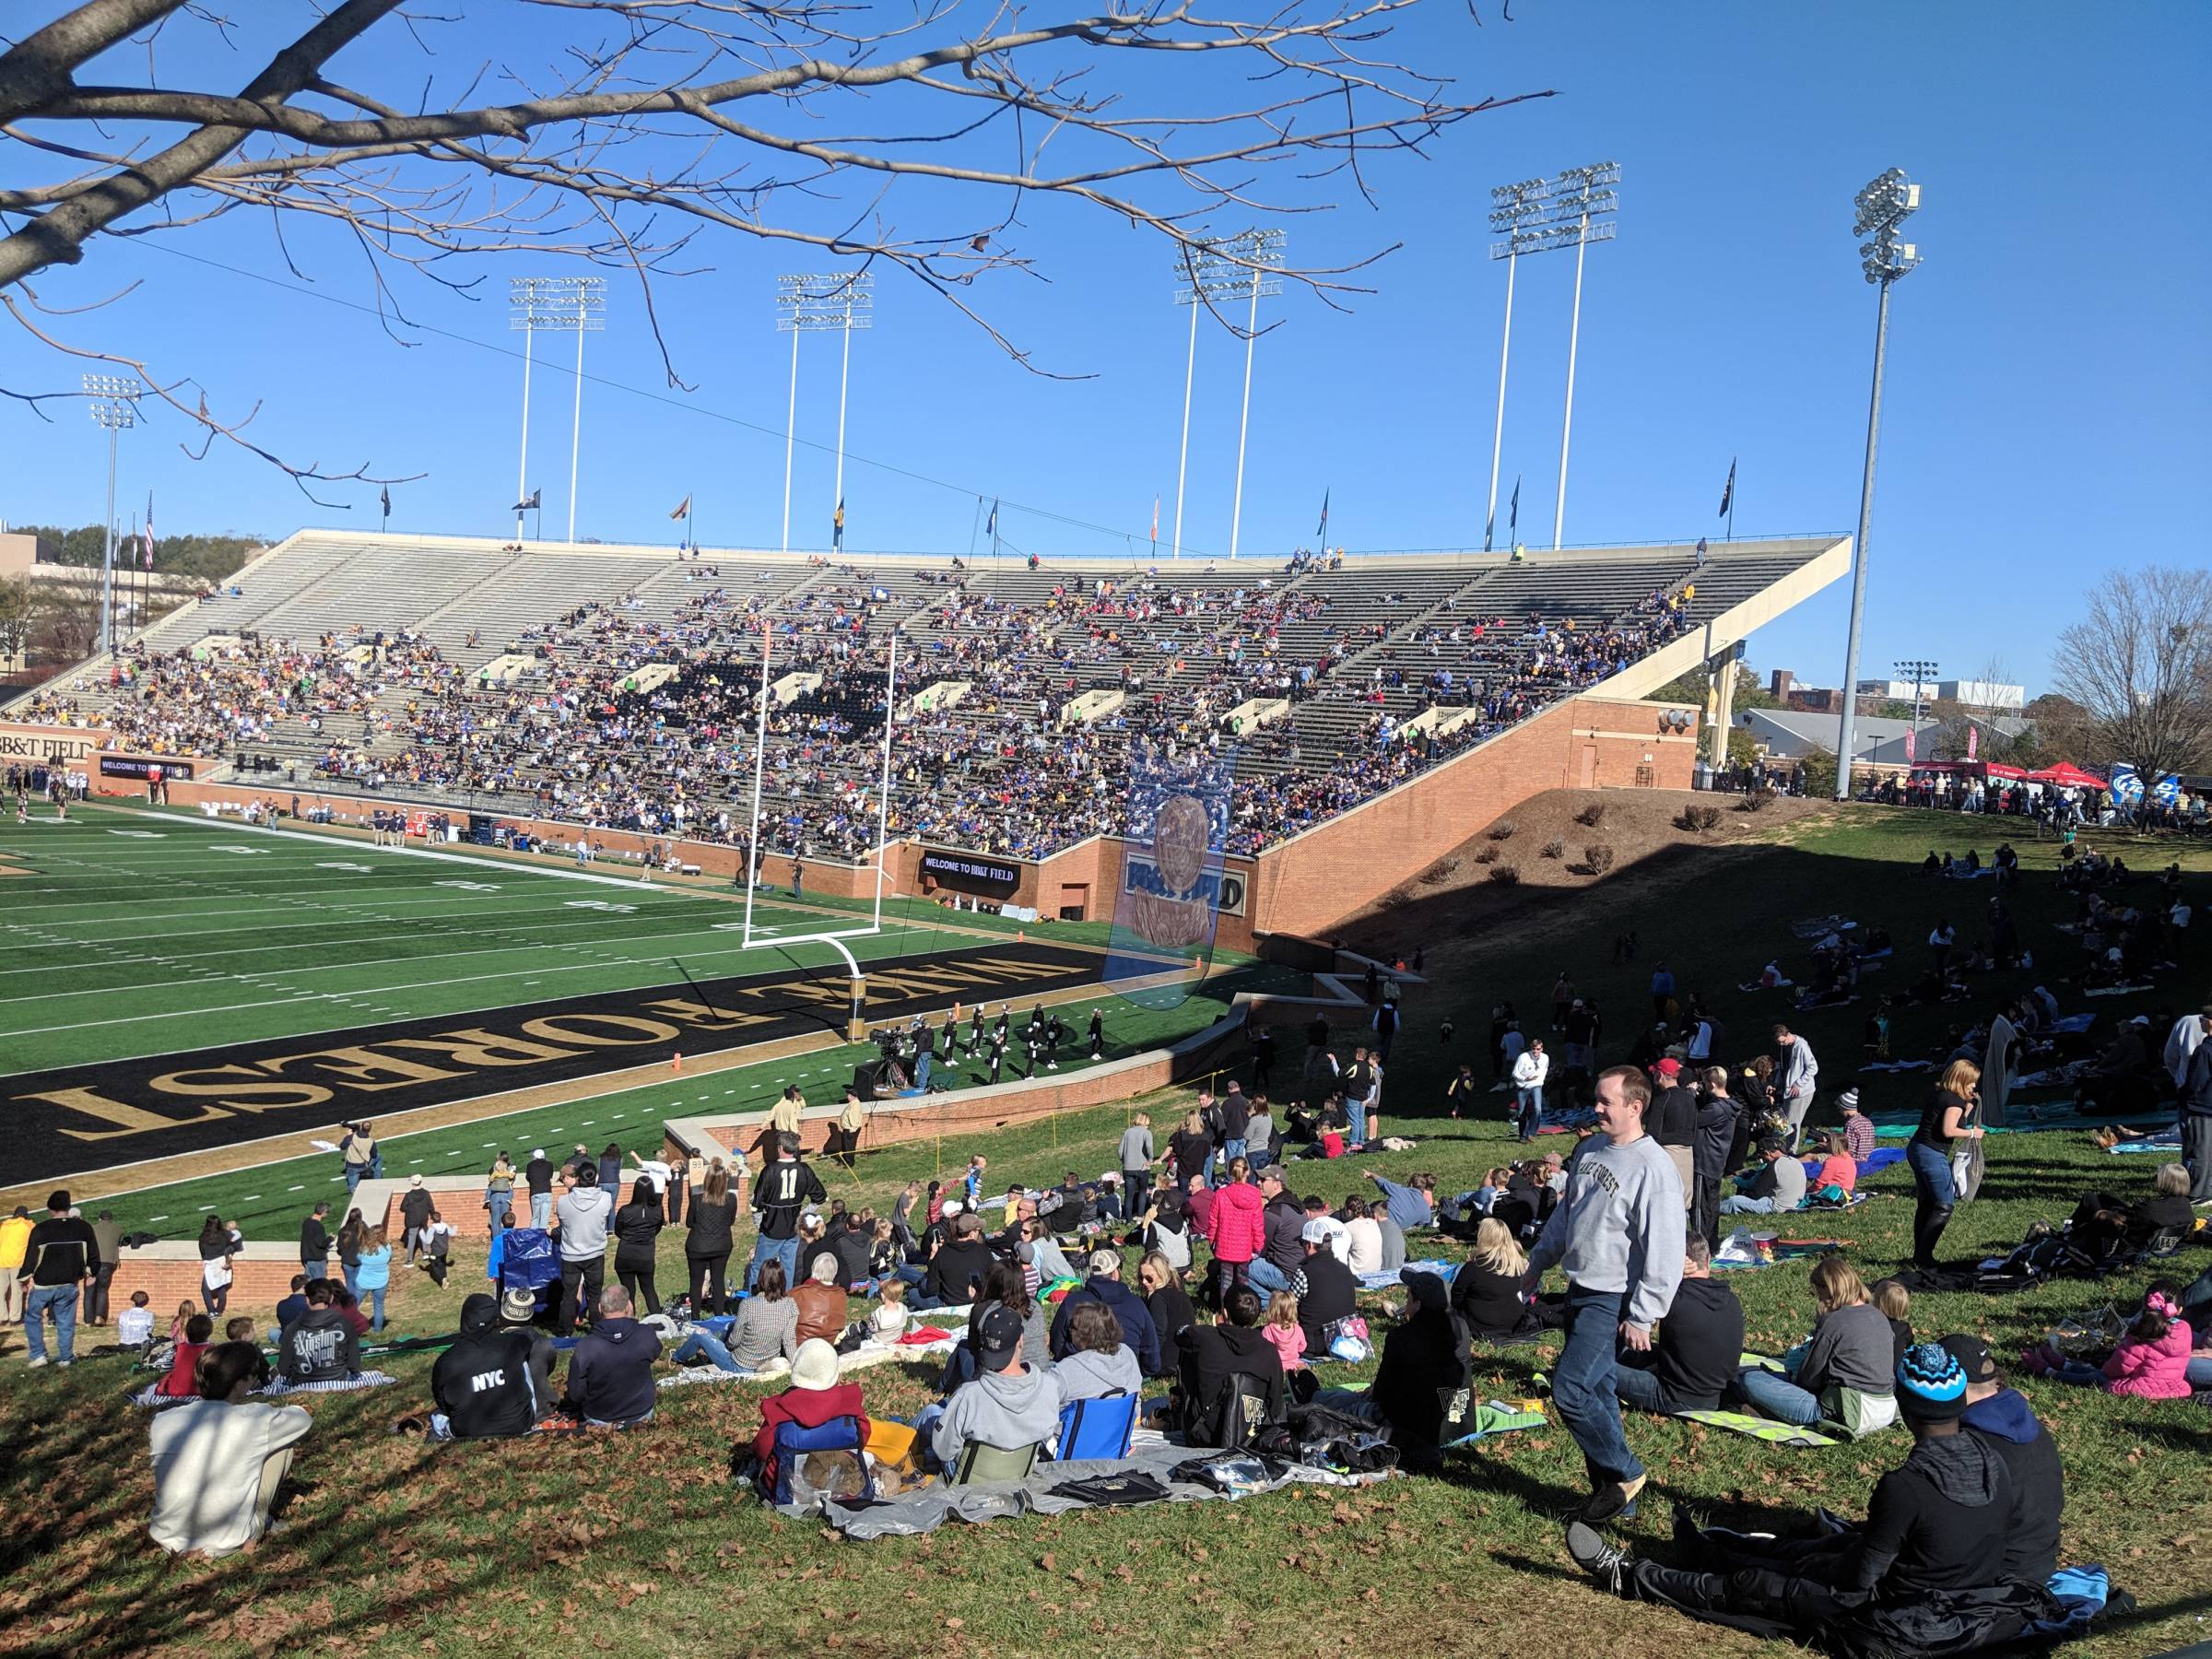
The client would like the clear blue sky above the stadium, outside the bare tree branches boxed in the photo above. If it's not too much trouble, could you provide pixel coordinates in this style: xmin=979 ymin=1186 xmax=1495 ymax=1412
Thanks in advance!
xmin=0 ymin=0 xmax=2212 ymax=688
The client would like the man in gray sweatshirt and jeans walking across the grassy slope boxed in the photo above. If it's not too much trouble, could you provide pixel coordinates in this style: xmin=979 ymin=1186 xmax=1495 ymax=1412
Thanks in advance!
xmin=1526 ymin=1066 xmax=1688 ymax=1522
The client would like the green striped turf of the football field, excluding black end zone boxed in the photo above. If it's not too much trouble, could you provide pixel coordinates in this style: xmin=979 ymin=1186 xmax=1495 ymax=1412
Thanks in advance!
xmin=0 ymin=806 xmax=1305 ymax=1239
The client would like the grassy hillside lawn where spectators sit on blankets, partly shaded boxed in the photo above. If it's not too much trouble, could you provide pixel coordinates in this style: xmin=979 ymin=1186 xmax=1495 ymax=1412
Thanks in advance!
xmin=0 ymin=809 xmax=2212 ymax=1657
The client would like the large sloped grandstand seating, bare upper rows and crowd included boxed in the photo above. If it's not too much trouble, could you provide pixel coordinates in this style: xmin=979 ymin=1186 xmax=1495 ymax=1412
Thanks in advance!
xmin=11 ymin=533 xmax=1820 ymax=858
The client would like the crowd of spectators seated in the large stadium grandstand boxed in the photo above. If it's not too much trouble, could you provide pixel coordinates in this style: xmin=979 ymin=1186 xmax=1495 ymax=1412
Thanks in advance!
xmin=4 ymin=562 xmax=1694 ymax=861
